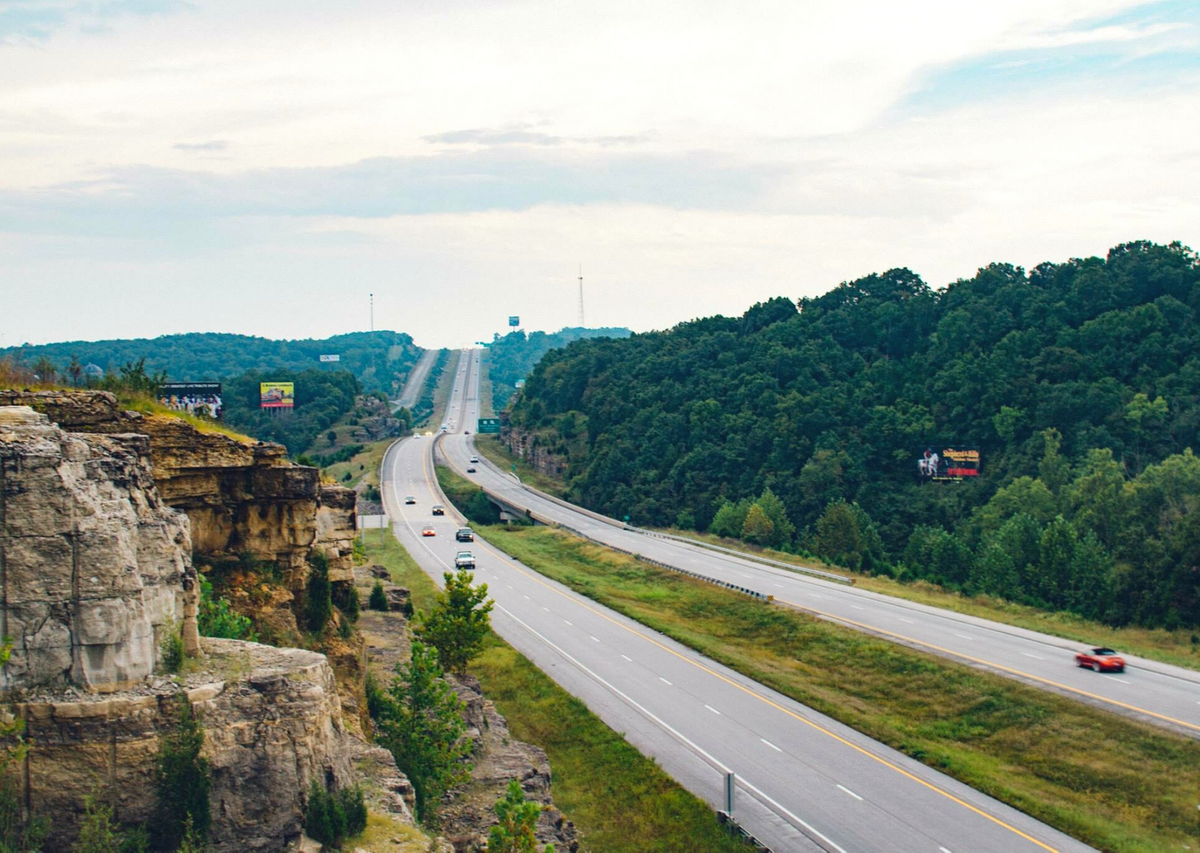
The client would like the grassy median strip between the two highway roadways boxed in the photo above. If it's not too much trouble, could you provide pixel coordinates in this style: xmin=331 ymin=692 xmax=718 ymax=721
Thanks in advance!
xmin=476 ymin=525 xmax=1200 ymax=851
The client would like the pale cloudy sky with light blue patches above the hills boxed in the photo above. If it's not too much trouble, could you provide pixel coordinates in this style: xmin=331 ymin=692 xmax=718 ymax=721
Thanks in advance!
xmin=0 ymin=0 xmax=1200 ymax=347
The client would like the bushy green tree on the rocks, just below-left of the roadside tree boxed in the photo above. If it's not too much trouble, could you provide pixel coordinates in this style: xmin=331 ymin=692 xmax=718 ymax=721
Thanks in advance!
xmin=374 ymin=639 xmax=470 ymax=825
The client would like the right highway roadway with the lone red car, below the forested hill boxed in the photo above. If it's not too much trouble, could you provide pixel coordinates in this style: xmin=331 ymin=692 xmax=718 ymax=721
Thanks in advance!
xmin=443 ymin=353 xmax=1200 ymax=738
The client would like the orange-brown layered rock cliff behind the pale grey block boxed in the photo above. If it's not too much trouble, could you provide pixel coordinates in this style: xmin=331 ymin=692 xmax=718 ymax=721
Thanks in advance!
xmin=0 ymin=390 xmax=356 ymax=589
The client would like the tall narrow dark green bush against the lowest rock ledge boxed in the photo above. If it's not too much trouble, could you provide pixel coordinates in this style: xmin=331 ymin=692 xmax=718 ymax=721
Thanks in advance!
xmin=151 ymin=699 xmax=212 ymax=849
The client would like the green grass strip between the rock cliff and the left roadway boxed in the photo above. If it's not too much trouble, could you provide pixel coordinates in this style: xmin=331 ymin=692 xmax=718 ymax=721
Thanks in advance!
xmin=367 ymin=536 xmax=746 ymax=853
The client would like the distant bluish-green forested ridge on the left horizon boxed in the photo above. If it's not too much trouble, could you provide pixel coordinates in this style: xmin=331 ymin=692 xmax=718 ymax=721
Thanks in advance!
xmin=0 ymin=331 xmax=421 ymax=395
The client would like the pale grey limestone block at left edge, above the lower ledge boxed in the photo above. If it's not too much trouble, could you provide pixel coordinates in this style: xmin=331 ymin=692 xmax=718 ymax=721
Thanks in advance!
xmin=0 ymin=407 xmax=191 ymax=696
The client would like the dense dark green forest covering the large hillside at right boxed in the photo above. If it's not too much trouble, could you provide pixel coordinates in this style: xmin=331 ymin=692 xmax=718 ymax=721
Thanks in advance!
xmin=511 ymin=242 xmax=1200 ymax=627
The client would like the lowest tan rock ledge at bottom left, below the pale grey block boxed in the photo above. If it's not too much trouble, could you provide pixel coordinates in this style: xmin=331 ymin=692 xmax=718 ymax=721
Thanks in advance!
xmin=14 ymin=638 xmax=354 ymax=853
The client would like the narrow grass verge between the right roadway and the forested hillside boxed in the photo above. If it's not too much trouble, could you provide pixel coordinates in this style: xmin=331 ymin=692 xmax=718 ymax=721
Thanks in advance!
xmin=657 ymin=527 xmax=1200 ymax=669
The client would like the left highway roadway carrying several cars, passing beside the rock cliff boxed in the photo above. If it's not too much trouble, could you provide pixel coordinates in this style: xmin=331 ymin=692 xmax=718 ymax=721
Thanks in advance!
xmin=383 ymin=350 xmax=1088 ymax=853
